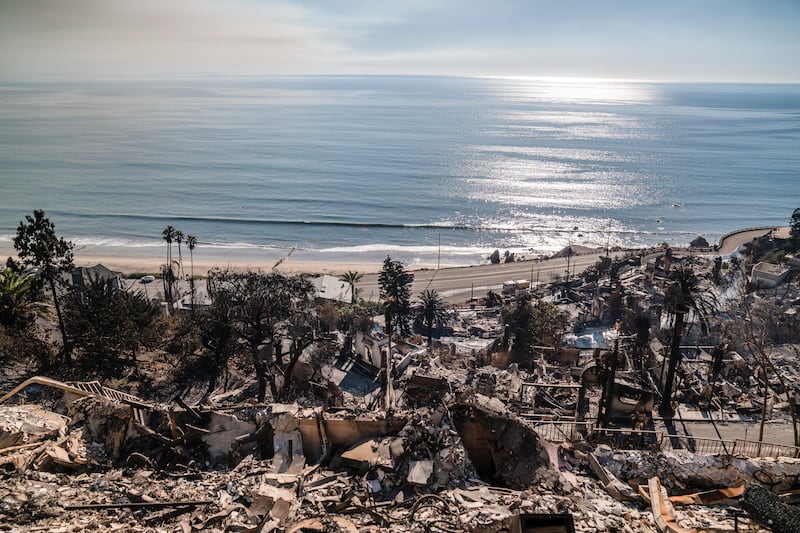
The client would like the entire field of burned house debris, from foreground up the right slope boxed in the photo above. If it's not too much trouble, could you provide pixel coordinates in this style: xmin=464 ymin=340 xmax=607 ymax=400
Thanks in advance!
xmin=0 ymin=240 xmax=800 ymax=532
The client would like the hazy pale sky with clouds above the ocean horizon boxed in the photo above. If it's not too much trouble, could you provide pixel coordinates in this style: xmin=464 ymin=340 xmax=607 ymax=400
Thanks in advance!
xmin=0 ymin=0 xmax=800 ymax=82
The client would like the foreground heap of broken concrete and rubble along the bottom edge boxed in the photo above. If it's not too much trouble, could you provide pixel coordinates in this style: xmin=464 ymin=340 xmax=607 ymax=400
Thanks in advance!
xmin=0 ymin=369 xmax=800 ymax=533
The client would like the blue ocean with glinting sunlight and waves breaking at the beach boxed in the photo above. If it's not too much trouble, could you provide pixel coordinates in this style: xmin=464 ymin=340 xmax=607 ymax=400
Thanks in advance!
xmin=0 ymin=76 xmax=800 ymax=266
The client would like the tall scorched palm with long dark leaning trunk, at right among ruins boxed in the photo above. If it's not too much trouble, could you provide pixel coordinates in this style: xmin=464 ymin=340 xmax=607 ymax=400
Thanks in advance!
xmin=659 ymin=265 xmax=717 ymax=416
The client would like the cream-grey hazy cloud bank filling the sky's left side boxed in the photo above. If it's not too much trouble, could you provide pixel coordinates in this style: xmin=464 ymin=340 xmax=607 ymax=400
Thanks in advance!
xmin=0 ymin=0 xmax=342 ymax=77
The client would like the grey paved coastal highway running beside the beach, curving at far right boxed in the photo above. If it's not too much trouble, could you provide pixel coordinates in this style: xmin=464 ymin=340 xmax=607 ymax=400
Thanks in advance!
xmin=357 ymin=228 xmax=788 ymax=303
